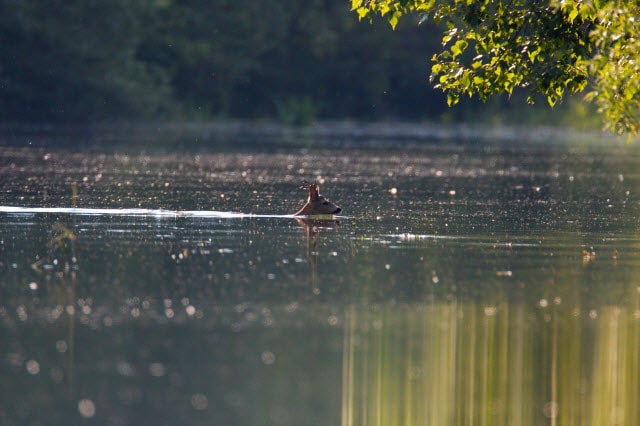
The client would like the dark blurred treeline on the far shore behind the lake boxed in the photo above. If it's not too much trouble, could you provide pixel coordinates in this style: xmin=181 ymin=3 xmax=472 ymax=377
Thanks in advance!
xmin=0 ymin=0 xmax=584 ymax=124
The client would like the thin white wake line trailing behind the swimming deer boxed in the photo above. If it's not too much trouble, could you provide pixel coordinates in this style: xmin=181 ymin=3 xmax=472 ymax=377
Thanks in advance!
xmin=0 ymin=206 xmax=293 ymax=219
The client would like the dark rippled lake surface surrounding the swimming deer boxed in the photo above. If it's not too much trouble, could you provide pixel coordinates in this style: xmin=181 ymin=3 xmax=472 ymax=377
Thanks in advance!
xmin=0 ymin=125 xmax=640 ymax=426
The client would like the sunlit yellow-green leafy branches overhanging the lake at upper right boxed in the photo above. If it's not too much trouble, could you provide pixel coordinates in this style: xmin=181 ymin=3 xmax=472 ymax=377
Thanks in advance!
xmin=352 ymin=0 xmax=640 ymax=134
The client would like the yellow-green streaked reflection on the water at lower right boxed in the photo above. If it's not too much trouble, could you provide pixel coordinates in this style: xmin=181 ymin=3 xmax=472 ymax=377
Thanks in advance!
xmin=342 ymin=302 xmax=640 ymax=425
